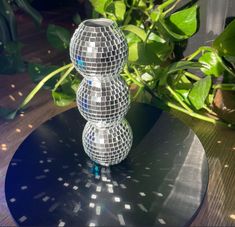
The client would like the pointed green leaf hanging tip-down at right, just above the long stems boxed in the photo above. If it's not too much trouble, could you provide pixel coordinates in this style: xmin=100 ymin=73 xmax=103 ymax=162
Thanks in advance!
xmin=188 ymin=76 xmax=211 ymax=110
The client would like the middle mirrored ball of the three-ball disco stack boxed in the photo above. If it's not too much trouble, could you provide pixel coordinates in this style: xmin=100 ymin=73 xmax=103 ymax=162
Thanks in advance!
xmin=77 ymin=77 xmax=130 ymax=124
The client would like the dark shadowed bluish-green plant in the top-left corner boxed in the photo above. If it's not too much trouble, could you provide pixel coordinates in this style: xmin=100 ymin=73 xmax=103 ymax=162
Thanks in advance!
xmin=0 ymin=0 xmax=42 ymax=74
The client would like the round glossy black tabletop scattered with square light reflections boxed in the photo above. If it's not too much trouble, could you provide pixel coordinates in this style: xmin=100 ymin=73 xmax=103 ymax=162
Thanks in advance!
xmin=5 ymin=104 xmax=208 ymax=227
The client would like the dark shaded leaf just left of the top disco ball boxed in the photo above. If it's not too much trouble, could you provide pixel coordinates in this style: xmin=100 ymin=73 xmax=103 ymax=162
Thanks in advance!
xmin=47 ymin=24 xmax=71 ymax=50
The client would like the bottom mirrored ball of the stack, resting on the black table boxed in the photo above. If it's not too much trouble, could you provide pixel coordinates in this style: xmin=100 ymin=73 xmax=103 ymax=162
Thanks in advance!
xmin=82 ymin=120 xmax=133 ymax=166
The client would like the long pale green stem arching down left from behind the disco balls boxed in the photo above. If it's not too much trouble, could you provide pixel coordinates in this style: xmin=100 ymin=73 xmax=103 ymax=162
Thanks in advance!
xmin=17 ymin=63 xmax=72 ymax=110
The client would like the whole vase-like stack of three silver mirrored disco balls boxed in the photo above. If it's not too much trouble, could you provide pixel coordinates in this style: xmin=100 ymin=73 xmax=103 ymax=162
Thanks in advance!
xmin=70 ymin=18 xmax=133 ymax=166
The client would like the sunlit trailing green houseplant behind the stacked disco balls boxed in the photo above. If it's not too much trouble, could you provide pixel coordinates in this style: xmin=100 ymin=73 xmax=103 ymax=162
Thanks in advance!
xmin=1 ymin=0 xmax=235 ymax=127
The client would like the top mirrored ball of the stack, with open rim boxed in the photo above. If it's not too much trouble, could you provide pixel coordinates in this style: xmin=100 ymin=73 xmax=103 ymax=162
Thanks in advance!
xmin=70 ymin=18 xmax=128 ymax=79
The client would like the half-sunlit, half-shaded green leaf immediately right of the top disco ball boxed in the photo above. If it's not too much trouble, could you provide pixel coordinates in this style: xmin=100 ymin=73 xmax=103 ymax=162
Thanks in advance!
xmin=128 ymin=42 xmax=160 ymax=65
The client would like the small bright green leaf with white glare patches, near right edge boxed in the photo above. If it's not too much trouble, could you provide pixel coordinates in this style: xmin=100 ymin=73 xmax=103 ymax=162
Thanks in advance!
xmin=198 ymin=52 xmax=224 ymax=77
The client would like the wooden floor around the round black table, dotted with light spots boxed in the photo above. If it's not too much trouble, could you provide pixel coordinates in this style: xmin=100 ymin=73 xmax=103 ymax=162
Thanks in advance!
xmin=0 ymin=4 xmax=235 ymax=226
